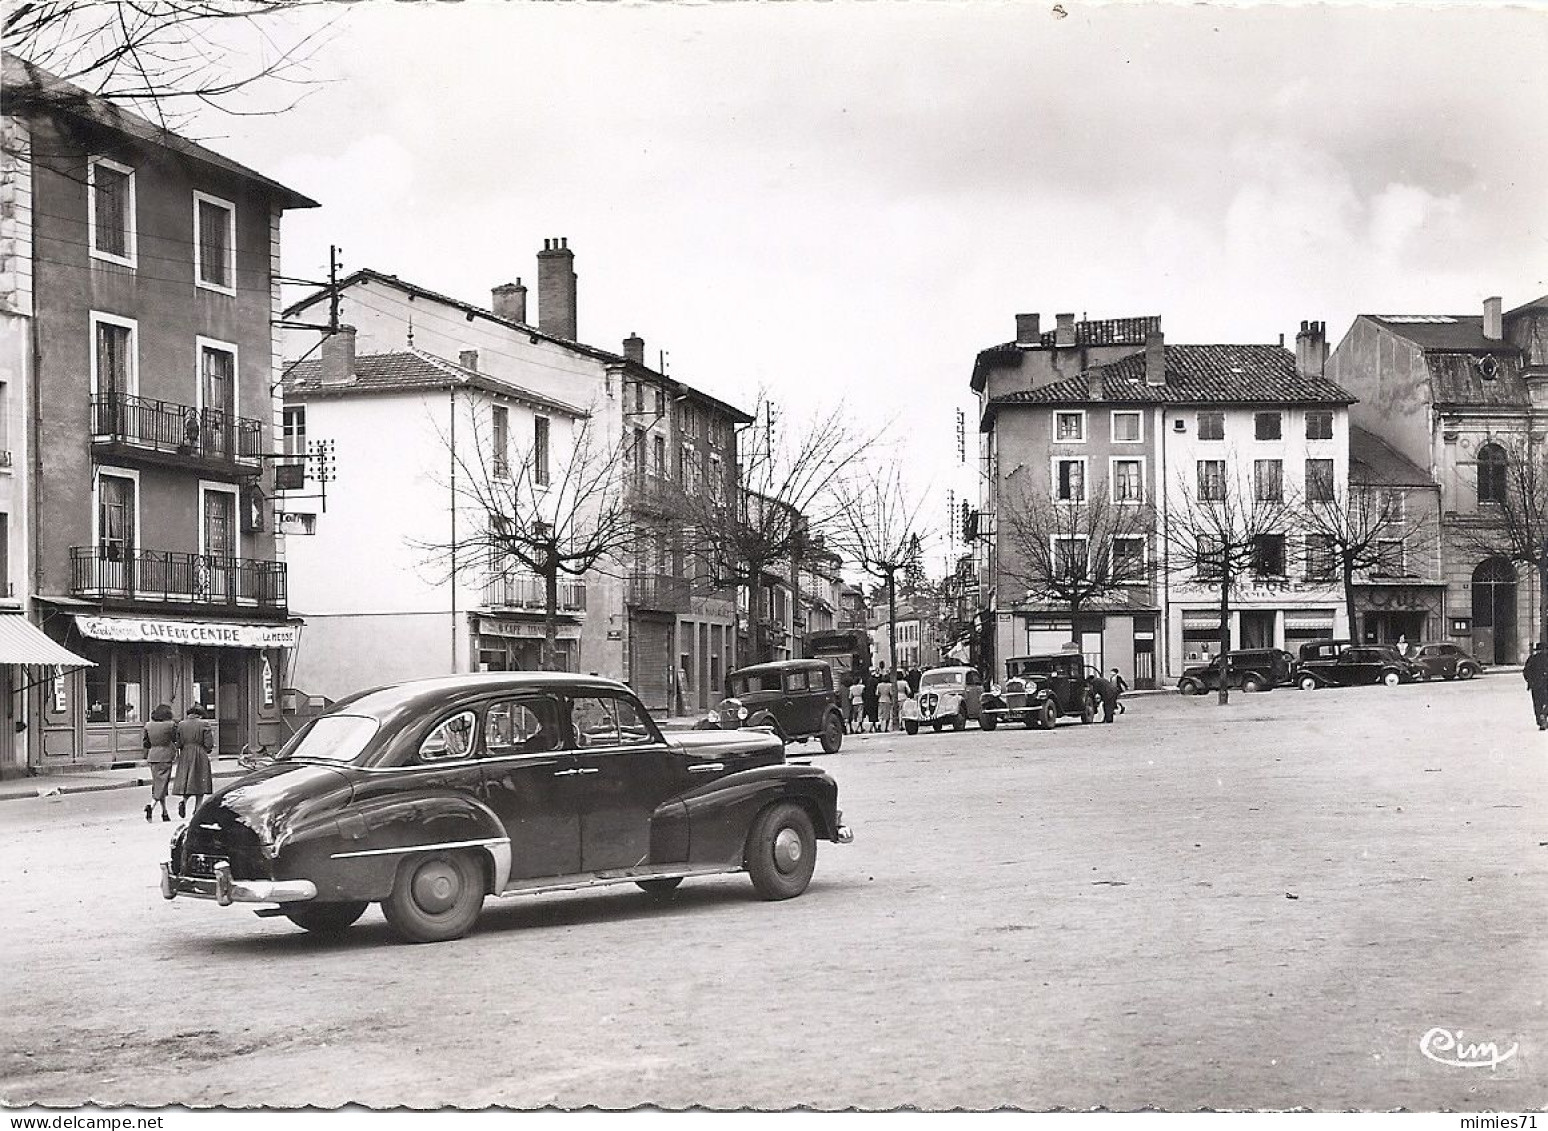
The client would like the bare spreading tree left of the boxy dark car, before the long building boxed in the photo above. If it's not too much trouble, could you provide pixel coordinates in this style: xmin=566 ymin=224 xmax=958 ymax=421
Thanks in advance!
xmin=672 ymin=396 xmax=873 ymax=662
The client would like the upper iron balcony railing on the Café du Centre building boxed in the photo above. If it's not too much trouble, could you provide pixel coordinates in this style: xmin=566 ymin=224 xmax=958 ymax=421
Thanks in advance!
xmin=91 ymin=393 xmax=263 ymax=464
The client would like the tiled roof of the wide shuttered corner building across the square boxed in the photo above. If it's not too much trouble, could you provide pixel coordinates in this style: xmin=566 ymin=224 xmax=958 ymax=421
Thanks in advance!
xmin=989 ymin=345 xmax=1356 ymax=408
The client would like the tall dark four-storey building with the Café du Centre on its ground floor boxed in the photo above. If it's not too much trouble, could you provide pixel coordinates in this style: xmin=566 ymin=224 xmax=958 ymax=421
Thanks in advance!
xmin=5 ymin=56 xmax=314 ymax=769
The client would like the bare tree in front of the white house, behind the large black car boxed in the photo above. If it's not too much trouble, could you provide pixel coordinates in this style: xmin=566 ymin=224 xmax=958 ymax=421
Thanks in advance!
xmin=420 ymin=395 xmax=636 ymax=671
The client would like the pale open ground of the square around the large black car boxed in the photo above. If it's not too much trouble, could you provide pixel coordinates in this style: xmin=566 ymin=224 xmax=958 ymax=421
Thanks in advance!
xmin=0 ymin=676 xmax=1548 ymax=1111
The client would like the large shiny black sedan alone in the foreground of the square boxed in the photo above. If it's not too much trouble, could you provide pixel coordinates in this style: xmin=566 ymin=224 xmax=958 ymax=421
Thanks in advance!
xmin=161 ymin=673 xmax=851 ymax=942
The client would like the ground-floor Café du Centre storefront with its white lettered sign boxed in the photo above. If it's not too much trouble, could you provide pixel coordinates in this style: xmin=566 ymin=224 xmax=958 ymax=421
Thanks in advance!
xmin=34 ymin=613 xmax=300 ymax=769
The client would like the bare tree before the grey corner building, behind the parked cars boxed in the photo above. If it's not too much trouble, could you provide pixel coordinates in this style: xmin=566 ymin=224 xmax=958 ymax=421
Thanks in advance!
xmin=1000 ymin=481 xmax=1155 ymax=644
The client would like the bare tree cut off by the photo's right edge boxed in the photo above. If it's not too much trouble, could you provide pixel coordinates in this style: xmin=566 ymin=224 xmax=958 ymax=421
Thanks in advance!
xmin=1458 ymin=436 xmax=1548 ymax=648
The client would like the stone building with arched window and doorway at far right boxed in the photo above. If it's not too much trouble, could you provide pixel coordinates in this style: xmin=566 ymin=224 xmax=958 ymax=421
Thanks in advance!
xmin=1328 ymin=296 xmax=1548 ymax=664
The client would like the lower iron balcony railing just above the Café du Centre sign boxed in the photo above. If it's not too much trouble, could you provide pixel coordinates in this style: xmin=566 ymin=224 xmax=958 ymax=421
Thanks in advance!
xmin=70 ymin=546 xmax=286 ymax=613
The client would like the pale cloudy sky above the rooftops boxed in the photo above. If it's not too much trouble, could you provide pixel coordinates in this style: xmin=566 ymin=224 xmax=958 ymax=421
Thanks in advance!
xmin=187 ymin=0 xmax=1548 ymax=572
